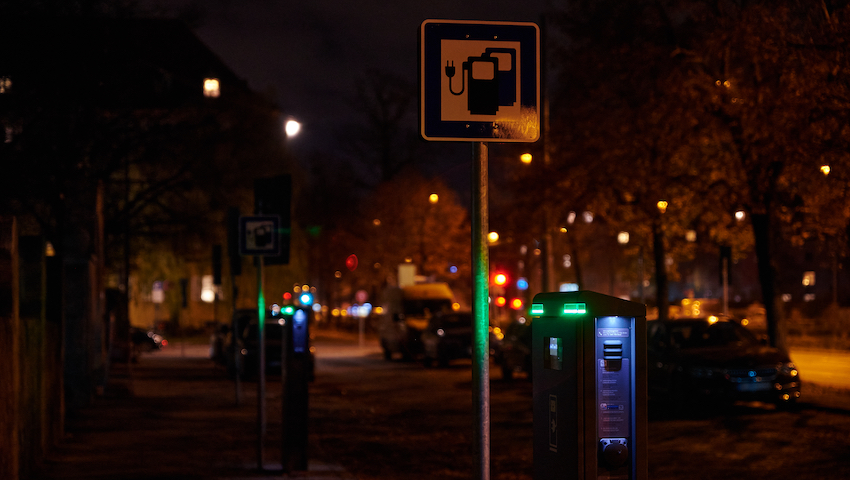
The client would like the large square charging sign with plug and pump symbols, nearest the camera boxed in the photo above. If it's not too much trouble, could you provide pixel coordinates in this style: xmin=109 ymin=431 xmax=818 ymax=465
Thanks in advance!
xmin=419 ymin=20 xmax=540 ymax=142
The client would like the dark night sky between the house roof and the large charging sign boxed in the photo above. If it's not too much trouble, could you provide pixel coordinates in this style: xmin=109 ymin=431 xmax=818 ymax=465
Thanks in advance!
xmin=146 ymin=0 xmax=552 ymax=161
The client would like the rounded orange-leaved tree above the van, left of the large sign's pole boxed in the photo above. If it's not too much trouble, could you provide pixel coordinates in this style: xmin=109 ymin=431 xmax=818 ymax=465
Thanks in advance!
xmin=322 ymin=170 xmax=472 ymax=308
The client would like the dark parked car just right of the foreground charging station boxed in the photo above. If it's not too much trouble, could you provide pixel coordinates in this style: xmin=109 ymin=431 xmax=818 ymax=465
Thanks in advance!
xmin=647 ymin=316 xmax=800 ymax=408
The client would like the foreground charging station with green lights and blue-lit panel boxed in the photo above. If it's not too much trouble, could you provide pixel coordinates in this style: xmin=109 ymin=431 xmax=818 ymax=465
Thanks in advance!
xmin=531 ymin=291 xmax=647 ymax=480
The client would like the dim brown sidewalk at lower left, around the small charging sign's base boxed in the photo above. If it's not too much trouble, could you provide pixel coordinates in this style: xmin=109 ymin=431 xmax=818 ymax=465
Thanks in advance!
xmin=37 ymin=336 xmax=364 ymax=480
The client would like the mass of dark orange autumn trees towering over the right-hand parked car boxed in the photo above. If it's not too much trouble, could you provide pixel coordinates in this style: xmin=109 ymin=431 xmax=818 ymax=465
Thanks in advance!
xmin=550 ymin=0 xmax=850 ymax=344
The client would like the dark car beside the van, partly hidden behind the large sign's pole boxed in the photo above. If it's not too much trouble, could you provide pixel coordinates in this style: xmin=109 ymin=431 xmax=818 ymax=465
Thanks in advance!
xmin=420 ymin=312 xmax=500 ymax=367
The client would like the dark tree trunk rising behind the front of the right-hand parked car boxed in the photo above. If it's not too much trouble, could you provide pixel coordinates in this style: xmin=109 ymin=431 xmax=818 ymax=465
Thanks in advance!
xmin=752 ymin=213 xmax=785 ymax=348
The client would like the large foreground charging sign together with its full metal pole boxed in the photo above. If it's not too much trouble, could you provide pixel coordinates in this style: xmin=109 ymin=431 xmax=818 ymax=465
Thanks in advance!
xmin=419 ymin=20 xmax=540 ymax=480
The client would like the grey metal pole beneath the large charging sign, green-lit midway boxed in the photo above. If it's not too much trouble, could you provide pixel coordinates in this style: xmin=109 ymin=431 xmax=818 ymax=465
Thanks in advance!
xmin=472 ymin=142 xmax=490 ymax=480
